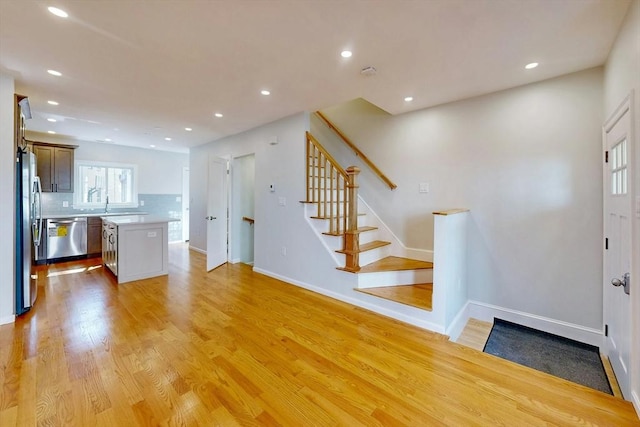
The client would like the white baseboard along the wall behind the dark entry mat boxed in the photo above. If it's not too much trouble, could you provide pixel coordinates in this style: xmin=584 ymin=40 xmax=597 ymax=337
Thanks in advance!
xmin=460 ymin=301 xmax=602 ymax=347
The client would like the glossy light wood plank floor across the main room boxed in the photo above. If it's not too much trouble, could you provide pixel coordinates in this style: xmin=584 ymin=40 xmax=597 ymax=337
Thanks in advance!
xmin=0 ymin=245 xmax=640 ymax=427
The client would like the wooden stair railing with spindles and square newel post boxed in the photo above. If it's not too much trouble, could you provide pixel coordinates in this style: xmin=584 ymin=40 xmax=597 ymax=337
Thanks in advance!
xmin=306 ymin=132 xmax=360 ymax=271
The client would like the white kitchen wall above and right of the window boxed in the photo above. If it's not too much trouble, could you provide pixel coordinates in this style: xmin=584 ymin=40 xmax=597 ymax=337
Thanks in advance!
xmin=27 ymin=132 xmax=189 ymax=194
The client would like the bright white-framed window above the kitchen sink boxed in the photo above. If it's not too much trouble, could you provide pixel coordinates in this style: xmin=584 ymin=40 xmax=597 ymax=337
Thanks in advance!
xmin=75 ymin=160 xmax=138 ymax=209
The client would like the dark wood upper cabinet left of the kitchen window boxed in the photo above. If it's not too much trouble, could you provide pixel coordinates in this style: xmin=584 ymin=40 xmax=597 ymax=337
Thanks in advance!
xmin=33 ymin=142 xmax=76 ymax=193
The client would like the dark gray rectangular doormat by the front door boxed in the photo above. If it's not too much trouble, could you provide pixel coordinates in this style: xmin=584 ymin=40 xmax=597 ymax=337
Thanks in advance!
xmin=483 ymin=318 xmax=613 ymax=394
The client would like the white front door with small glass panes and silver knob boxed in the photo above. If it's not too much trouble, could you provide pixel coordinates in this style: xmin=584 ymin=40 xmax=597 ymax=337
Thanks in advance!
xmin=603 ymin=95 xmax=638 ymax=399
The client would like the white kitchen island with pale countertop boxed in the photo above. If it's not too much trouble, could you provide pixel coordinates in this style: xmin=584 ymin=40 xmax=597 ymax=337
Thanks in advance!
xmin=102 ymin=215 xmax=178 ymax=283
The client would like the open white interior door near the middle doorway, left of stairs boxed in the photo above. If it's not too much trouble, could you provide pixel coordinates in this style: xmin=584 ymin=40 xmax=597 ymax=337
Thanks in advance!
xmin=205 ymin=157 xmax=228 ymax=271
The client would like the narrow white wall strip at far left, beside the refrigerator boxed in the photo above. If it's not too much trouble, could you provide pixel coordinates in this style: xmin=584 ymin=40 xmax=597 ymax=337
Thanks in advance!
xmin=0 ymin=74 xmax=16 ymax=325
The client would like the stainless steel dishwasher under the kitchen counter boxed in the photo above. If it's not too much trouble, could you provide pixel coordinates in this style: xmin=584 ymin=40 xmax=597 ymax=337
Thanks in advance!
xmin=47 ymin=217 xmax=87 ymax=259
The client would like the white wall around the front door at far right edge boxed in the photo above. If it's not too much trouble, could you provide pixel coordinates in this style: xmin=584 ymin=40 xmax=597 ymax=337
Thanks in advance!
xmin=601 ymin=0 xmax=640 ymax=414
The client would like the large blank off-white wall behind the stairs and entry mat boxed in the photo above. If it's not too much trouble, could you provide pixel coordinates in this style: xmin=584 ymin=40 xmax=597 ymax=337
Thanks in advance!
xmin=314 ymin=68 xmax=603 ymax=330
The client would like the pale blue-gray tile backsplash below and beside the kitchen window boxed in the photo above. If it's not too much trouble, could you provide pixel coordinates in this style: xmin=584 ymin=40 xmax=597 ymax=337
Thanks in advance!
xmin=42 ymin=193 xmax=182 ymax=242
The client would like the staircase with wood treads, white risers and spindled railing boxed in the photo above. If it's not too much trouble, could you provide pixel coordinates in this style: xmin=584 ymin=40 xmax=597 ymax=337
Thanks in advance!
xmin=303 ymin=132 xmax=433 ymax=311
